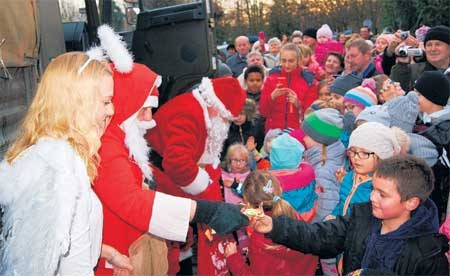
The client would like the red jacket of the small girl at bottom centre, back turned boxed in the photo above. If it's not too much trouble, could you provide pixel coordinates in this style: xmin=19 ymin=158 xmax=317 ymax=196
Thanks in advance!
xmin=227 ymin=220 xmax=318 ymax=275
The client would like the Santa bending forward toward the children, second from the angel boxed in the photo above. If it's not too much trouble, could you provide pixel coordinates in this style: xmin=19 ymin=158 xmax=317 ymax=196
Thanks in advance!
xmin=146 ymin=75 xmax=246 ymax=275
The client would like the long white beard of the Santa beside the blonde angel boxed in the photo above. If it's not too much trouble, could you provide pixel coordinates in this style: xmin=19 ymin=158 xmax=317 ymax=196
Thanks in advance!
xmin=123 ymin=119 xmax=156 ymax=180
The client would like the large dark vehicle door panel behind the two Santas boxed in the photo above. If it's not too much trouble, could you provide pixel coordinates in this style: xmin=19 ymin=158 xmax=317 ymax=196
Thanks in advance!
xmin=132 ymin=0 xmax=215 ymax=103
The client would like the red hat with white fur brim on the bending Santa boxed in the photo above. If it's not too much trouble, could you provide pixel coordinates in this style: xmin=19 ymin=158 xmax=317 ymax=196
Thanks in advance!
xmin=198 ymin=77 xmax=247 ymax=119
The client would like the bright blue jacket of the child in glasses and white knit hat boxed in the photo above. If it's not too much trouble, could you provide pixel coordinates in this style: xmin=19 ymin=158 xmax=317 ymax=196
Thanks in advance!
xmin=332 ymin=171 xmax=372 ymax=216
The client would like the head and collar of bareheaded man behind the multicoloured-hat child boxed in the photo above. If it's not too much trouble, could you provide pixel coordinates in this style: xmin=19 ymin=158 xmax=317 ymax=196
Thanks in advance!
xmin=345 ymin=39 xmax=378 ymax=79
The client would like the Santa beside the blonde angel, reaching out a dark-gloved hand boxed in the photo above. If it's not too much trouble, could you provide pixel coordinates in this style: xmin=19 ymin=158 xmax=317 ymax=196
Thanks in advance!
xmin=94 ymin=63 xmax=250 ymax=275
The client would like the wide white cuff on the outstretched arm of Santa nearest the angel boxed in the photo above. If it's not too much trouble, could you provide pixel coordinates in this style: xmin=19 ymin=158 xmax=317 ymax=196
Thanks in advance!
xmin=149 ymin=192 xmax=191 ymax=241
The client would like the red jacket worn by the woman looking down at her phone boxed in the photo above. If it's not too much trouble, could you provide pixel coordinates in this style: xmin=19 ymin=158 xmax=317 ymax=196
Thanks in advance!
xmin=259 ymin=67 xmax=318 ymax=132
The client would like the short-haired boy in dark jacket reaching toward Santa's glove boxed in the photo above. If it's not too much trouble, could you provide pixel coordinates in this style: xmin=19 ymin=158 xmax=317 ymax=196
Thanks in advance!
xmin=252 ymin=156 xmax=449 ymax=275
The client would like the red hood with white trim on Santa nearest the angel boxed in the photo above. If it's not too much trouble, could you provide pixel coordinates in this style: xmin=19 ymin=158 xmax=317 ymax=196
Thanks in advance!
xmin=111 ymin=63 xmax=161 ymax=125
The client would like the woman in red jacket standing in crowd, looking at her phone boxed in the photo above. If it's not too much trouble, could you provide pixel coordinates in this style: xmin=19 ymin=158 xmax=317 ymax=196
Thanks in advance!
xmin=259 ymin=43 xmax=317 ymax=133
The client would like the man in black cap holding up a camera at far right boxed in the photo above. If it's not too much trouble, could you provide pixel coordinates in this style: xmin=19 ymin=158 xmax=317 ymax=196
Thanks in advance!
xmin=383 ymin=26 xmax=450 ymax=91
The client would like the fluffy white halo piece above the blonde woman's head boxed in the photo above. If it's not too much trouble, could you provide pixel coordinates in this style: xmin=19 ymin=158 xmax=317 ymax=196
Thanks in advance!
xmin=97 ymin=25 xmax=133 ymax=73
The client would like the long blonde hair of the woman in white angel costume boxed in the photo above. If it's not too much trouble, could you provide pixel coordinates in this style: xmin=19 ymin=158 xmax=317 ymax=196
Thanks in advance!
xmin=6 ymin=52 xmax=112 ymax=181
